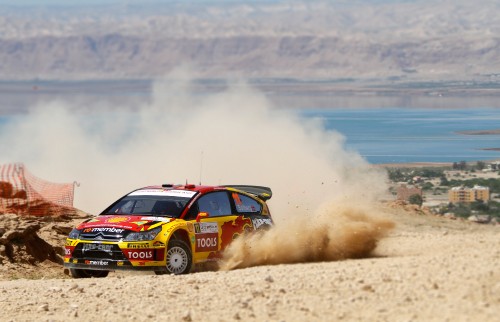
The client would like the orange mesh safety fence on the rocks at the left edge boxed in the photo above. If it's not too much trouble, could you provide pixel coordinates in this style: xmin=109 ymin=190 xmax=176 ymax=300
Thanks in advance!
xmin=0 ymin=163 xmax=75 ymax=215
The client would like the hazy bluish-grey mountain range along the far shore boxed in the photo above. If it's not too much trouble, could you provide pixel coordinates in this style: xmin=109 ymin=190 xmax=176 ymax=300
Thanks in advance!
xmin=0 ymin=0 xmax=500 ymax=83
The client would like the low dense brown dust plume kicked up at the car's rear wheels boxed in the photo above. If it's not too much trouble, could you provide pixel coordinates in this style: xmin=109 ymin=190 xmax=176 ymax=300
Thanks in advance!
xmin=220 ymin=202 xmax=394 ymax=270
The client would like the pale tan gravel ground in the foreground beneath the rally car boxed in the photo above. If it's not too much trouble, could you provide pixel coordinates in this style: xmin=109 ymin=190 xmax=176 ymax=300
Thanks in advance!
xmin=0 ymin=210 xmax=500 ymax=321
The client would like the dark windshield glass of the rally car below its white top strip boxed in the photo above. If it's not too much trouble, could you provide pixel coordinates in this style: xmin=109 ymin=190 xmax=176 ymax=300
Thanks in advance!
xmin=103 ymin=195 xmax=191 ymax=218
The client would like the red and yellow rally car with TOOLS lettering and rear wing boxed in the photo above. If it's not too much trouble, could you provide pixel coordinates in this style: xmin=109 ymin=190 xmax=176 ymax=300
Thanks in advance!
xmin=64 ymin=184 xmax=273 ymax=278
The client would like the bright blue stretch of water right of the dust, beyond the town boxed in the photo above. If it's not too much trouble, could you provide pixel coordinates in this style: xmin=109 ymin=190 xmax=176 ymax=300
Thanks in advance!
xmin=301 ymin=108 xmax=500 ymax=164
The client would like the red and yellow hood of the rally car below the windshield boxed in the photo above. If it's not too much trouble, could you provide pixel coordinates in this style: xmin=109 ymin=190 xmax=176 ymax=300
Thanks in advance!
xmin=76 ymin=215 xmax=175 ymax=231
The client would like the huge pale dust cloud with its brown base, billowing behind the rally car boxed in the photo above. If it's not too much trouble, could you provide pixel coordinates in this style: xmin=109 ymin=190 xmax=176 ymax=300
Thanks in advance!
xmin=0 ymin=72 xmax=388 ymax=267
